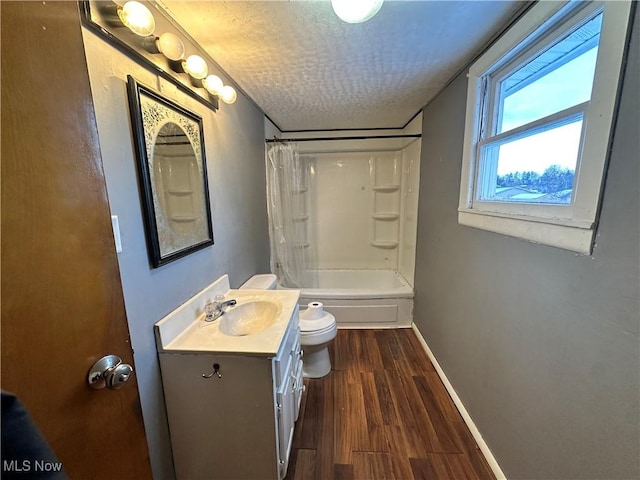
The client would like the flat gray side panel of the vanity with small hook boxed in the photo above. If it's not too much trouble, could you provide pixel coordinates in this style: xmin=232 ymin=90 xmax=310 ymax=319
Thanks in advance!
xmin=159 ymin=353 xmax=279 ymax=480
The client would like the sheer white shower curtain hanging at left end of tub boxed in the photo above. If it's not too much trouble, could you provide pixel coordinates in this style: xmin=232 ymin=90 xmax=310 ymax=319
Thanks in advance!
xmin=267 ymin=143 xmax=307 ymax=287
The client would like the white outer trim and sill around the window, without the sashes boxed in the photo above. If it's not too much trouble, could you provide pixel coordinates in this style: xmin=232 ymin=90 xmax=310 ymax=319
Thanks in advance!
xmin=458 ymin=0 xmax=631 ymax=254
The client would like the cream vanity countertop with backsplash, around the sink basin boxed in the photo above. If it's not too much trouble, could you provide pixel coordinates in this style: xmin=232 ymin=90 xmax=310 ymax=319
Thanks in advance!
xmin=155 ymin=290 xmax=300 ymax=356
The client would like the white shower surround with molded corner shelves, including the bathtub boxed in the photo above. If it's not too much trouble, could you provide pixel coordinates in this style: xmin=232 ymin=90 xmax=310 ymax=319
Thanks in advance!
xmin=276 ymin=119 xmax=421 ymax=328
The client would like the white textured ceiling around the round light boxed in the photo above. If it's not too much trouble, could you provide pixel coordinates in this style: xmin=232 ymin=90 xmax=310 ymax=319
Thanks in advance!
xmin=158 ymin=0 xmax=523 ymax=131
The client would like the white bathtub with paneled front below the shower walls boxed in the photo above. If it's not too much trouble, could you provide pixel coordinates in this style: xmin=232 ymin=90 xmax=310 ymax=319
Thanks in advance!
xmin=278 ymin=270 xmax=413 ymax=328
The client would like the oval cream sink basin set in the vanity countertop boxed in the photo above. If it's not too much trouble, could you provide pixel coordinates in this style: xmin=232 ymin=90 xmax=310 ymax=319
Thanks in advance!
xmin=220 ymin=300 xmax=280 ymax=337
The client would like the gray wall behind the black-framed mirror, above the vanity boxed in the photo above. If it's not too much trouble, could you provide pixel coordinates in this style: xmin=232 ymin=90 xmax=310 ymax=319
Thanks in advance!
xmin=83 ymin=30 xmax=269 ymax=479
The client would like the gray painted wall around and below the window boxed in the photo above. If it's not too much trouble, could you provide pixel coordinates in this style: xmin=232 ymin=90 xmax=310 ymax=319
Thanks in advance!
xmin=415 ymin=8 xmax=640 ymax=479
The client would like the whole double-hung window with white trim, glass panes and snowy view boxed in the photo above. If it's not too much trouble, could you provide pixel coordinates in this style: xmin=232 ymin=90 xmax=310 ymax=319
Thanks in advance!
xmin=458 ymin=1 xmax=630 ymax=253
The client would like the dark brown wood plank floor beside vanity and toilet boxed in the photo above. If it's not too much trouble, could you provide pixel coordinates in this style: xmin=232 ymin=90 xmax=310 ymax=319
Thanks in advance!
xmin=286 ymin=329 xmax=495 ymax=480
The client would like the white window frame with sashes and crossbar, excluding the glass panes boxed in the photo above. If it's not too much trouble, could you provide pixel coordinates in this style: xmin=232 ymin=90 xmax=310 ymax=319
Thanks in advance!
xmin=458 ymin=0 xmax=631 ymax=254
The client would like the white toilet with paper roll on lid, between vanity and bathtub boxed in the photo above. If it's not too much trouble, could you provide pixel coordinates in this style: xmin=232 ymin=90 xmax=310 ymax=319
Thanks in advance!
xmin=240 ymin=274 xmax=338 ymax=378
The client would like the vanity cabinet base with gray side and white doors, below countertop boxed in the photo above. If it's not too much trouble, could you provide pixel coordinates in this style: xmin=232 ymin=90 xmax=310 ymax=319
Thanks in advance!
xmin=159 ymin=308 xmax=304 ymax=480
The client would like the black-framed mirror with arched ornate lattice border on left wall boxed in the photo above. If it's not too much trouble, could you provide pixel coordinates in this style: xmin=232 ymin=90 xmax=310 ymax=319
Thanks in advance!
xmin=127 ymin=75 xmax=213 ymax=268
